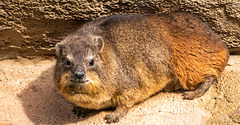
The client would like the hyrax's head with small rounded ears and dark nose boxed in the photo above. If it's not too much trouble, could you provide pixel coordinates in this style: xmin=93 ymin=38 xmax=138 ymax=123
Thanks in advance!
xmin=55 ymin=34 xmax=103 ymax=91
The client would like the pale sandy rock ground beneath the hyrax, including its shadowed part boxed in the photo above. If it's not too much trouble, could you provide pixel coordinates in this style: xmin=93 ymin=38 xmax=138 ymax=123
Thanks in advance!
xmin=0 ymin=56 xmax=240 ymax=125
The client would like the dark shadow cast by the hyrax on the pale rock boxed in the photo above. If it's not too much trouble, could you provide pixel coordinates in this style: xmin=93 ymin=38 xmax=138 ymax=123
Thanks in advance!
xmin=18 ymin=66 xmax=98 ymax=124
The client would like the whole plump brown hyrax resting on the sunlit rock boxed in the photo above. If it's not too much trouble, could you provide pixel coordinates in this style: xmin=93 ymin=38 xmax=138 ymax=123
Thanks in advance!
xmin=55 ymin=12 xmax=229 ymax=123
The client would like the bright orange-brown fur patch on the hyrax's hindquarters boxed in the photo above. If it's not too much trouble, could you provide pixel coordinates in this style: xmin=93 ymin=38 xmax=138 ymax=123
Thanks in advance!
xmin=171 ymin=34 xmax=228 ymax=90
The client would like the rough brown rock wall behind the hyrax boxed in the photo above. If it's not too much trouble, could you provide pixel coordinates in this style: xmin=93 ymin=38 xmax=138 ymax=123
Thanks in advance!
xmin=0 ymin=0 xmax=240 ymax=58
